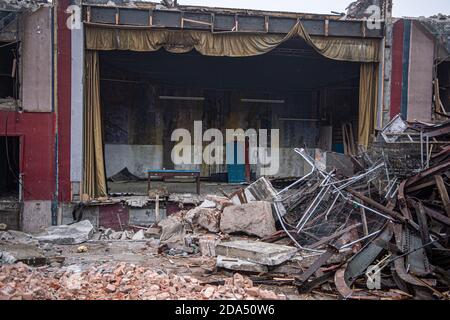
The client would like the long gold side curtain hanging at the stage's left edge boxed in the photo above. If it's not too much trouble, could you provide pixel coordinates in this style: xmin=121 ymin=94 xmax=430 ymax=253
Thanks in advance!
xmin=82 ymin=50 xmax=107 ymax=198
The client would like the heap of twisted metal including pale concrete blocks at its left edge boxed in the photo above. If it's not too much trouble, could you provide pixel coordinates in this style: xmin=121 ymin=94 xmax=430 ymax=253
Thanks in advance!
xmin=167 ymin=117 xmax=450 ymax=300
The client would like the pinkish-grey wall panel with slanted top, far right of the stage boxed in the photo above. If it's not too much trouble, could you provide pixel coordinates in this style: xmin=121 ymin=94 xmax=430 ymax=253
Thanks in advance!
xmin=408 ymin=22 xmax=434 ymax=121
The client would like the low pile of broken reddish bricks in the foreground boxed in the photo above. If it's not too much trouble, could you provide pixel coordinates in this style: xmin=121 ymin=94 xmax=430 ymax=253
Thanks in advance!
xmin=0 ymin=263 xmax=286 ymax=300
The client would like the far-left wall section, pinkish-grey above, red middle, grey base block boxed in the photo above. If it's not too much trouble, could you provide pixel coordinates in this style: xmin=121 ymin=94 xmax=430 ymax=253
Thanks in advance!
xmin=0 ymin=7 xmax=55 ymax=233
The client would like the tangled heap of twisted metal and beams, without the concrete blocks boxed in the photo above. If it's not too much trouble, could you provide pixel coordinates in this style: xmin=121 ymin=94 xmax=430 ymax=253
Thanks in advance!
xmin=250 ymin=121 xmax=450 ymax=300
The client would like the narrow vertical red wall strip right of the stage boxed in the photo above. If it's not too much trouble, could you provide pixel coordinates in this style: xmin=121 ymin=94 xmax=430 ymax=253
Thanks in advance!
xmin=391 ymin=20 xmax=404 ymax=119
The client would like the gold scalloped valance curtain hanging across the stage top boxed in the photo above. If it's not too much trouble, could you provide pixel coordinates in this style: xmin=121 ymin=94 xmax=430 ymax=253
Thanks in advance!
xmin=86 ymin=21 xmax=379 ymax=62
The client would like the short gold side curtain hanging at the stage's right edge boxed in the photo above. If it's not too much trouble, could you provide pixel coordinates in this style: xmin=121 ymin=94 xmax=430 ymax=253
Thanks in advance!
xmin=358 ymin=63 xmax=378 ymax=147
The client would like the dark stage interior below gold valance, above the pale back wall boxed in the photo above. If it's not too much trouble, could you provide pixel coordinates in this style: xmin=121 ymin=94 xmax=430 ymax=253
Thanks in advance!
xmin=100 ymin=39 xmax=360 ymax=181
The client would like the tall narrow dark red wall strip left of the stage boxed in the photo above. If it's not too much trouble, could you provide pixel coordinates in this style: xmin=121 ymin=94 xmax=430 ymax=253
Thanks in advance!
xmin=57 ymin=0 xmax=72 ymax=202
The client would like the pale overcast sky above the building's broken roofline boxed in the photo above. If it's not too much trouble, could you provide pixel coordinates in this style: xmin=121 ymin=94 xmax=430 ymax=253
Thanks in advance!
xmin=178 ymin=0 xmax=450 ymax=17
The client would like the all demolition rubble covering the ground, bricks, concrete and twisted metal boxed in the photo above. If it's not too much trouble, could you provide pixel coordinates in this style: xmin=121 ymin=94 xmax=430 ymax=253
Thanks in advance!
xmin=0 ymin=117 xmax=450 ymax=300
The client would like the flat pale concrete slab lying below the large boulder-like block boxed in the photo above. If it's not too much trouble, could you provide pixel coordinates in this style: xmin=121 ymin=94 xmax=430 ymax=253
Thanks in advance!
xmin=216 ymin=240 xmax=298 ymax=266
